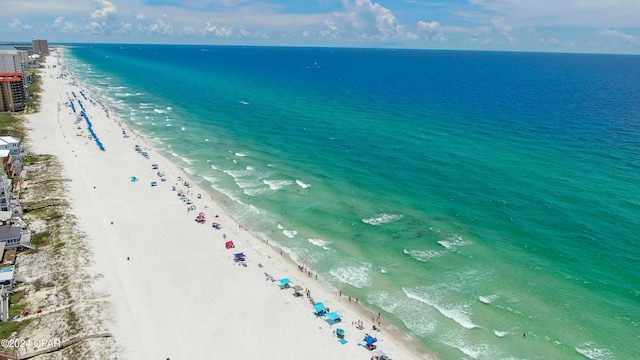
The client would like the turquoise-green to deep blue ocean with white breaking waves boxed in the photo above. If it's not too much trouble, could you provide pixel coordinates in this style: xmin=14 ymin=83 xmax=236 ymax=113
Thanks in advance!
xmin=57 ymin=44 xmax=640 ymax=360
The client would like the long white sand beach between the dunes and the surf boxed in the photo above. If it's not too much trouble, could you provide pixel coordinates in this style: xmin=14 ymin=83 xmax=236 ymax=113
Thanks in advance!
xmin=28 ymin=51 xmax=431 ymax=360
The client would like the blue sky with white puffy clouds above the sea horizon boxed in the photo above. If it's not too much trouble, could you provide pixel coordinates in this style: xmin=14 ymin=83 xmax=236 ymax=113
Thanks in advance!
xmin=0 ymin=0 xmax=640 ymax=54
